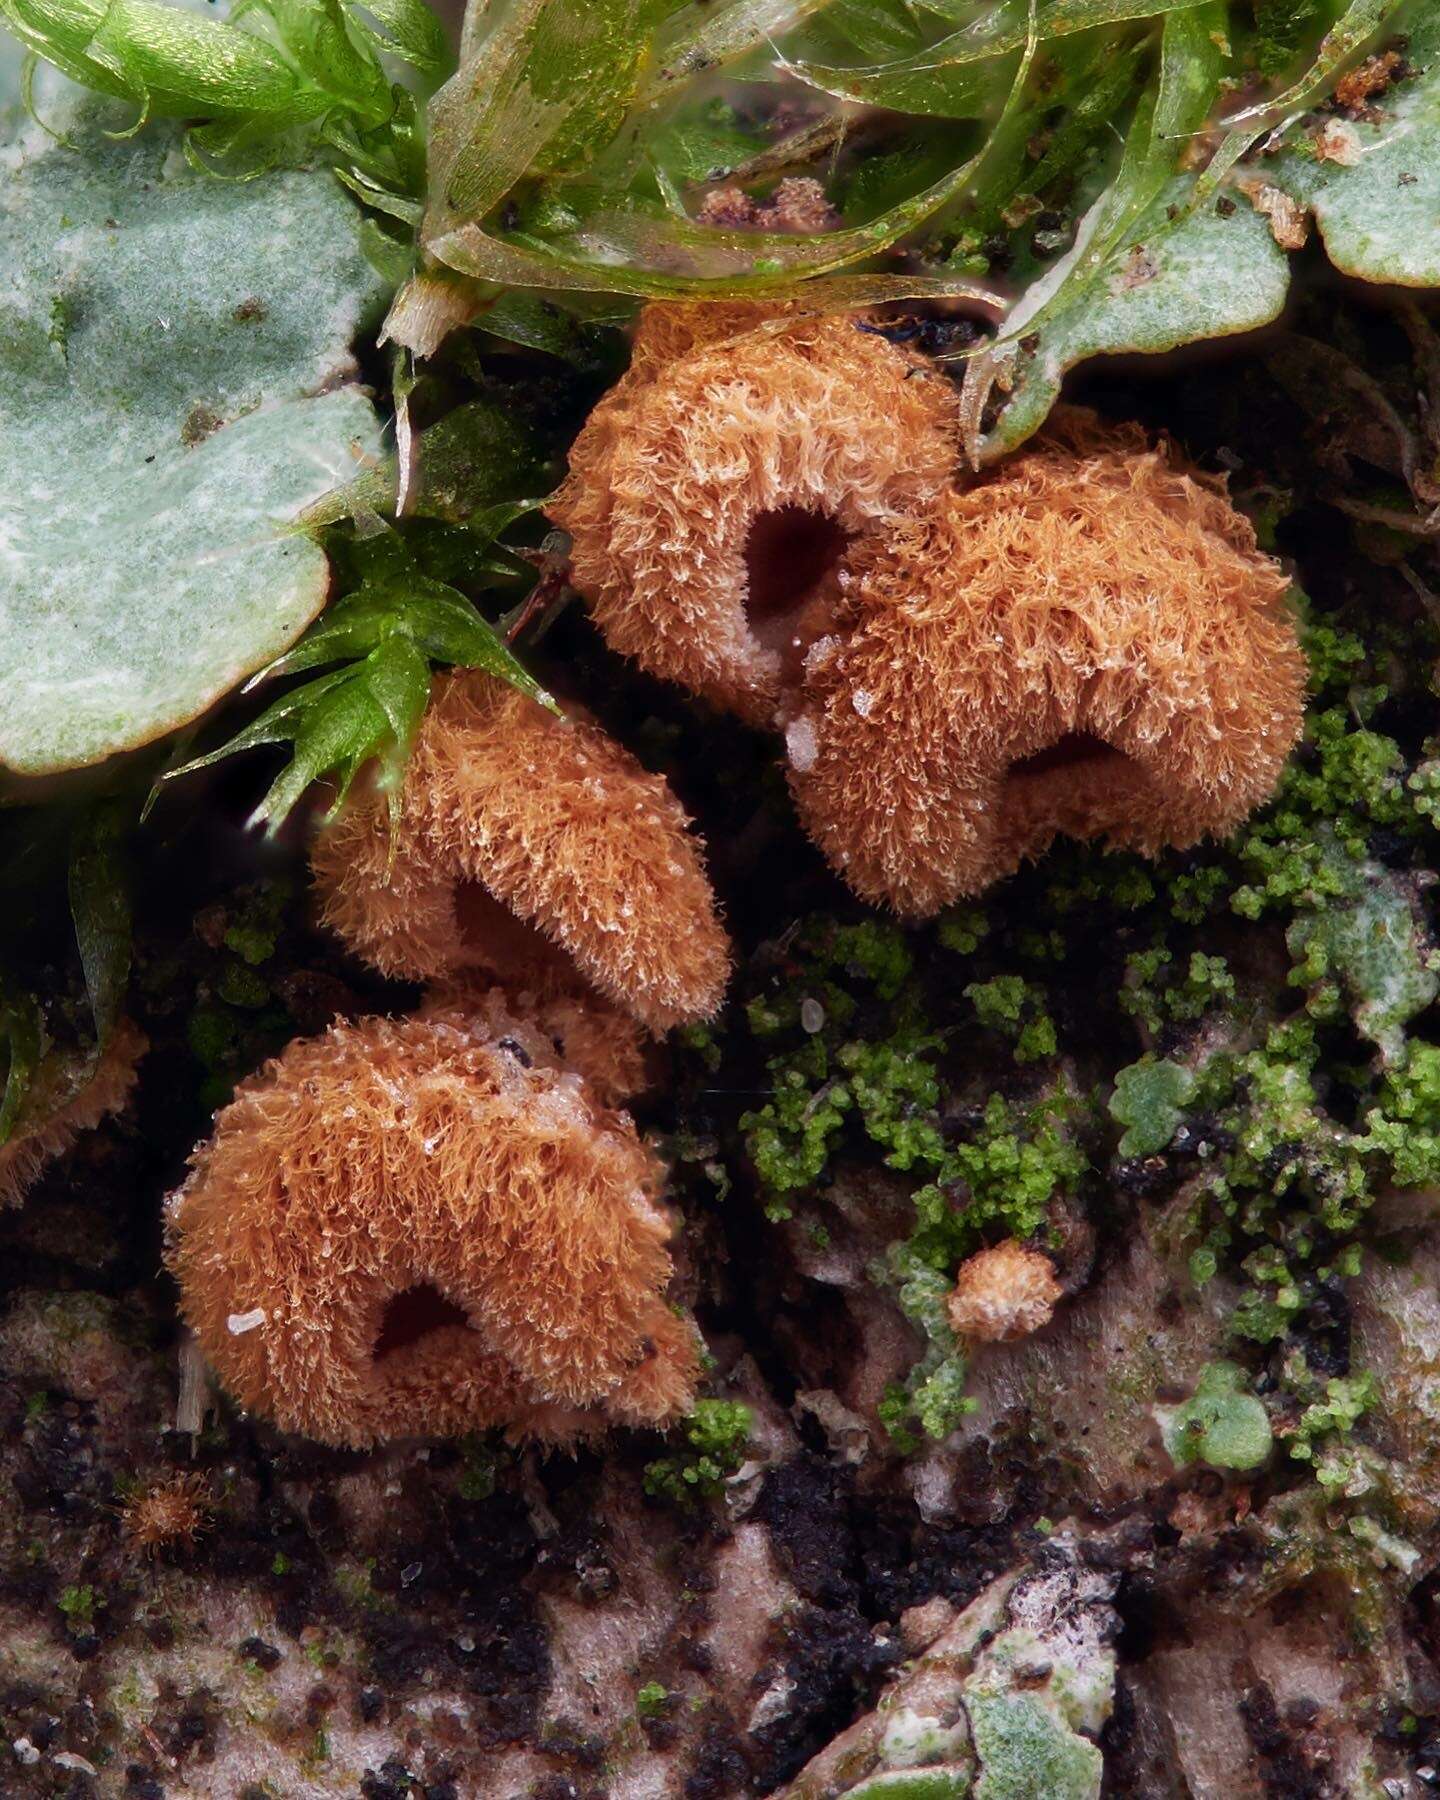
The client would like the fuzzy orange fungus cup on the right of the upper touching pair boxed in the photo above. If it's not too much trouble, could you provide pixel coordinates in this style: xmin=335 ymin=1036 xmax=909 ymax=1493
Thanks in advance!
xmin=787 ymin=410 xmax=1305 ymax=918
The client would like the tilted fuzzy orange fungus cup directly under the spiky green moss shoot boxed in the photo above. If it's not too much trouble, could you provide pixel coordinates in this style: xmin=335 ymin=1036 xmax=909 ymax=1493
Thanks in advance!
xmin=311 ymin=670 xmax=729 ymax=1031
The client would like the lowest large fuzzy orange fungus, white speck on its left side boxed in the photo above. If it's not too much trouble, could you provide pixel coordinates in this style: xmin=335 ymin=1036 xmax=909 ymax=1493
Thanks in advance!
xmin=167 ymin=1013 xmax=698 ymax=1447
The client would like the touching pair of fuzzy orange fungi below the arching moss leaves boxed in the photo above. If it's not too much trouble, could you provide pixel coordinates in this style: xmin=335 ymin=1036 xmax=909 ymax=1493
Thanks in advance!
xmin=551 ymin=306 xmax=1305 ymax=918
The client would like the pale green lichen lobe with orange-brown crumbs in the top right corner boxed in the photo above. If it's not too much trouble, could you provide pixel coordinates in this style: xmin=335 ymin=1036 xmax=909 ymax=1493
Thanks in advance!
xmin=1265 ymin=5 xmax=1440 ymax=288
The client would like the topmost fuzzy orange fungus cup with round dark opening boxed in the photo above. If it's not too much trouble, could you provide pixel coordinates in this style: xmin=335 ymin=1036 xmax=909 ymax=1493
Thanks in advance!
xmin=549 ymin=306 xmax=956 ymax=724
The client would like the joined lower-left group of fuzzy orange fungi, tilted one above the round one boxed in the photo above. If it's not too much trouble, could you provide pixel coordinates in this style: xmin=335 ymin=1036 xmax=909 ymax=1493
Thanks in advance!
xmin=169 ymin=670 xmax=729 ymax=1445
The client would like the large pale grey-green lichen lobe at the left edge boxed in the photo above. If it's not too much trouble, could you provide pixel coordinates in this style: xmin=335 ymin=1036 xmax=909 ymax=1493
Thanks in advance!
xmin=0 ymin=119 xmax=383 ymax=774
